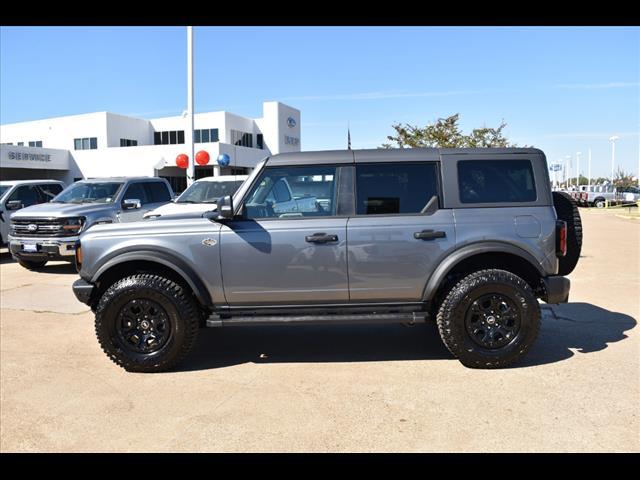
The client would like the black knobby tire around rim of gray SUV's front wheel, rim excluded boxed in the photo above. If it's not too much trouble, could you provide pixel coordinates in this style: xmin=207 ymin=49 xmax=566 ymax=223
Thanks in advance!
xmin=95 ymin=274 xmax=200 ymax=373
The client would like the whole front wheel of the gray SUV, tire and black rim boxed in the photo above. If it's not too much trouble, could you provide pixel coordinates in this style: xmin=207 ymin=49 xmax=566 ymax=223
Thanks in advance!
xmin=95 ymin=274 xmax=200 ymax=373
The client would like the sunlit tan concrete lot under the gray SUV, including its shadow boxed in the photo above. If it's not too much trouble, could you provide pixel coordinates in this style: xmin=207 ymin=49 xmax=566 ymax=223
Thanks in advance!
xmin=0 ymin=210 xmax=640 ymax=452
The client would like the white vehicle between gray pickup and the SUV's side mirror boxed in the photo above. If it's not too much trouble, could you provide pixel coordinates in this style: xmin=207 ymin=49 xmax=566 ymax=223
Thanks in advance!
xmin=144 ymin=175 xmax=248 ymax=219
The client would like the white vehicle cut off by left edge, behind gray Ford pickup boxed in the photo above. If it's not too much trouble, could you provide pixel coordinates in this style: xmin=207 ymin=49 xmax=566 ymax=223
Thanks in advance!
xmin=0 ymin=180 xmax=65 ymax=245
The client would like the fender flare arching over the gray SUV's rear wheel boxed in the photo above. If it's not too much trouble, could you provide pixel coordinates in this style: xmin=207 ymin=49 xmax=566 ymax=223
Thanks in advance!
xmin=422 ymin=241 xmax=545 ymax=300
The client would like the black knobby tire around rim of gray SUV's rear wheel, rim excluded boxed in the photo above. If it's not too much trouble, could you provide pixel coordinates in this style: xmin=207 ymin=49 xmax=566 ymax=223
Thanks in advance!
xmin=436 ymin=270 xmax=540 ymax=369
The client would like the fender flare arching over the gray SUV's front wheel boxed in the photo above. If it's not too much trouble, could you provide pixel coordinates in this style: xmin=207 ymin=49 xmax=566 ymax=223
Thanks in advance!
xmin=89 ymin=248 xmax=213 ymax=306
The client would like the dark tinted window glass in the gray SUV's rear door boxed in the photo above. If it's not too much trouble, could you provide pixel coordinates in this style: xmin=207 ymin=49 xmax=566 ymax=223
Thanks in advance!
xmin=356 ymin=162 xmax=439 ymax=215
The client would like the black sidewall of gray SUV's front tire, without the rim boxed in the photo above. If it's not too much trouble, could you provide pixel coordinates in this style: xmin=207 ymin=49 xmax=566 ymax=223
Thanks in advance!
xmin=96 ymin=281 xmax=186 ymax=368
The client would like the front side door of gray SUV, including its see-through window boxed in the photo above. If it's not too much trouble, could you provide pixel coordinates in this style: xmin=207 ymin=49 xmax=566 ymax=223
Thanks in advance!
xmin=220 ymin=165 xmax=349 ymax=306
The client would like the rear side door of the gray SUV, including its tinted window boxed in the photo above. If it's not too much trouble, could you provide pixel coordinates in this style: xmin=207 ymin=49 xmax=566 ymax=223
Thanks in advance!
xmin=347 ymin=150 xmax=456 ymax=302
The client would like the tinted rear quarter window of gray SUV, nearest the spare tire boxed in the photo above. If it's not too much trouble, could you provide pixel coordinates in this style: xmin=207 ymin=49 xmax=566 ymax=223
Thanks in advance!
xmin=458 ymin=160 xmax=538 ymax=203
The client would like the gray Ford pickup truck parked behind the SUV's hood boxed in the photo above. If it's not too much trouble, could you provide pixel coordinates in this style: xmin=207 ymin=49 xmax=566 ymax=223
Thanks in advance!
xmin=9 ymin=177 xmax=174 ymax=270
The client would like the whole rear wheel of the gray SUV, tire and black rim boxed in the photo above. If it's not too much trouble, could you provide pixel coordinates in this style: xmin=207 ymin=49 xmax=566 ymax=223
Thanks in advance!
xmin=436 ymin=270 xmax=540 ymax=368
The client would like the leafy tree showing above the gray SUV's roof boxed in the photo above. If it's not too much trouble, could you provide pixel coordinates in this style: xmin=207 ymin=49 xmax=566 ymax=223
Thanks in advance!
xmin=381 ymin=113 xmax=517 ymax=148
